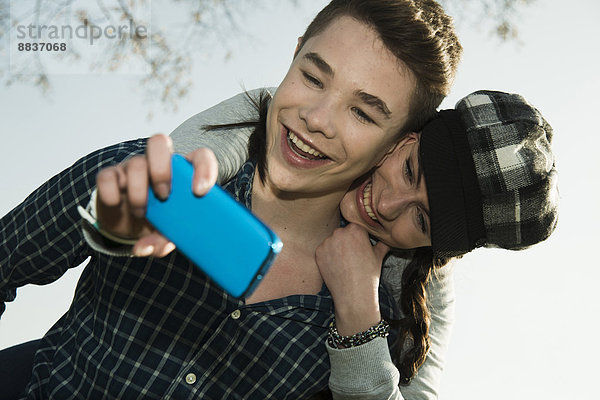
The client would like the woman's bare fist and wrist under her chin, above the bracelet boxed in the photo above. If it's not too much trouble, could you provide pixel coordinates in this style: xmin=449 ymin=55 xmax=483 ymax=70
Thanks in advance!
xmin=315 ymin=224 xmax=390 ymax=336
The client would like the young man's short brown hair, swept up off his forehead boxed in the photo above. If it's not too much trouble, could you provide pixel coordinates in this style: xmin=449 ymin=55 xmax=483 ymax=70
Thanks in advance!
xmin=298 ymin=0 xmax=462 ymax=133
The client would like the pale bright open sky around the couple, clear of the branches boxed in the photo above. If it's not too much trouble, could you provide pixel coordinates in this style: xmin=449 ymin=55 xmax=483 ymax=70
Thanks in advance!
xmin=0 ymin=0 xmax=600 ymax=400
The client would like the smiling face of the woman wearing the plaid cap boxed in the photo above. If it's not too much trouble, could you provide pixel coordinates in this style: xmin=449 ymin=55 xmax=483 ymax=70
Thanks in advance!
xmin=340 ymin=133 xmax=431 ymax=249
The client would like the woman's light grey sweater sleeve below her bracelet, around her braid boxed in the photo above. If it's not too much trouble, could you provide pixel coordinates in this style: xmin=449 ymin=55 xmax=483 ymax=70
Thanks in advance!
xmin=327 ymin=257 xmax=454 ymax=400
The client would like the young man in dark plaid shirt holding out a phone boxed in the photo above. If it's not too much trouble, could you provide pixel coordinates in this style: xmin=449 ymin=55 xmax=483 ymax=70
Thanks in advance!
xmin=0 ymin=0 xmax=460 ymax=399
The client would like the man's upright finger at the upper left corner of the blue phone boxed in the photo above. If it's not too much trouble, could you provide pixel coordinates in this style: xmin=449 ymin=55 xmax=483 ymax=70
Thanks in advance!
xmin=146 ymin=135 xmax=173 ymax=200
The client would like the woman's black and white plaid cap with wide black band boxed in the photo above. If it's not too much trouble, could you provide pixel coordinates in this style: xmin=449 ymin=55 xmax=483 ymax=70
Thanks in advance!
xmin=419 ymin=91 xmax=558 ymax=257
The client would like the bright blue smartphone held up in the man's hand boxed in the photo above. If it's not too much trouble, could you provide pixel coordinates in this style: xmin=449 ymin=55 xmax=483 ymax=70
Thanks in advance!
xmin=146 ymin=154 xmax=283 ymax=298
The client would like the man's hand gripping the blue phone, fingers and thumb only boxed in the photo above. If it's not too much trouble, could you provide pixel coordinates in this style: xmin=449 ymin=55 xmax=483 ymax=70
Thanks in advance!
xmin=96 ymin=135 xmax=218 ymax=257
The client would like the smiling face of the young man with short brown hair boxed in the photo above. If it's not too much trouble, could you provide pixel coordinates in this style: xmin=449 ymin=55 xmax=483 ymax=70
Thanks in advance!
xmin=266 ymin=17 xmax=415 ymax=196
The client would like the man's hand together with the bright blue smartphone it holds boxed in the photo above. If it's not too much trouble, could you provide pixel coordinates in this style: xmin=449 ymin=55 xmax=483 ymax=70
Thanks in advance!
xmin=96 ymin=135 xmax=282 ymax=297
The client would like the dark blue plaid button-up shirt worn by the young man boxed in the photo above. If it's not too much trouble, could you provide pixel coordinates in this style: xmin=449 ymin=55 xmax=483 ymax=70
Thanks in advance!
xmin=0 ymin=139 xmax=398 ymax=400
